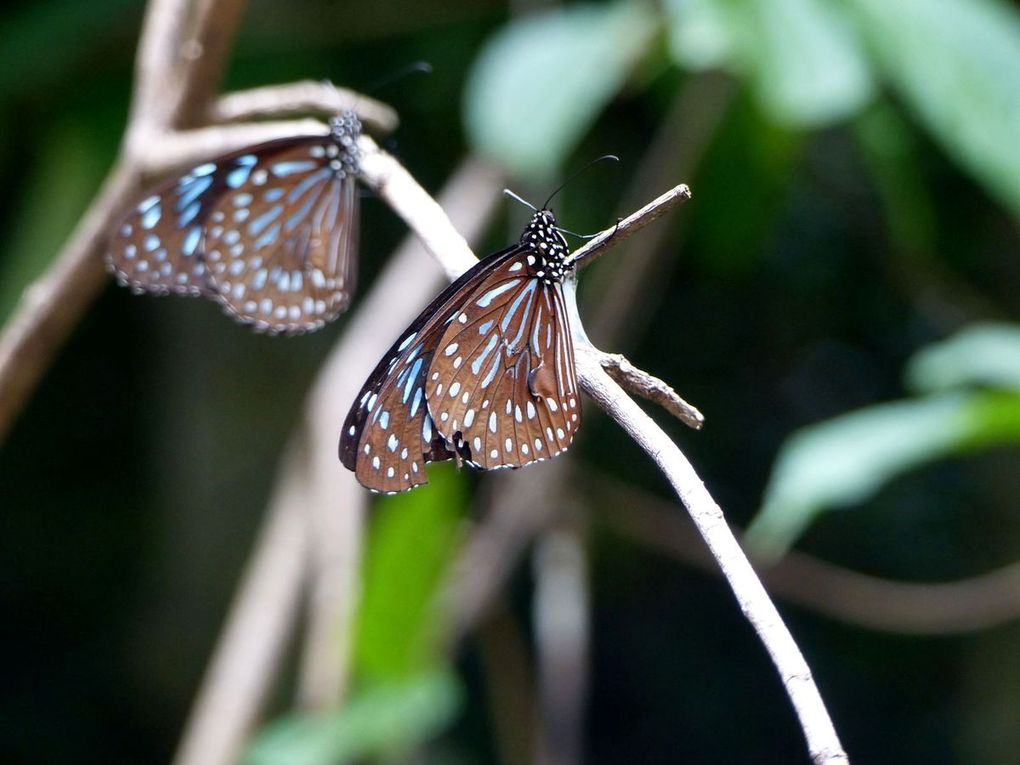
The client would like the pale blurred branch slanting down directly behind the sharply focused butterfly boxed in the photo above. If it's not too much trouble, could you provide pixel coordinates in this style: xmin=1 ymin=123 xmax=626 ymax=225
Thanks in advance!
xmin=293 ymin=159 xmax=503 ymax=708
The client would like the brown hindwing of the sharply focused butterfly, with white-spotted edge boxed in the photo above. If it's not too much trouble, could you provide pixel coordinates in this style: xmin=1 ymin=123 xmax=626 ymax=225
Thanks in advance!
xmin=425 ymin=252 xmax=580 ymax=470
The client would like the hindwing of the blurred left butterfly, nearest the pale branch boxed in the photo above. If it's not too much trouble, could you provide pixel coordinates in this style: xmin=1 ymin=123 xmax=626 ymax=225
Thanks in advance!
xmin=203 ymin=138 xmax=358 ymax=333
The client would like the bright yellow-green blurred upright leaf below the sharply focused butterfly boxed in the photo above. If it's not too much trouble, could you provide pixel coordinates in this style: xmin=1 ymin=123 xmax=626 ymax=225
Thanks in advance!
xmin=354 ymin=465 xmax=467 ymax=676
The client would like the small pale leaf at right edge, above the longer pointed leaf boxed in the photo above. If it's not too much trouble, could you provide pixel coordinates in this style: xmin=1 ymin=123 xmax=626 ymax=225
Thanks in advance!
xmin=907 ymin=323 xmax=1020 ymax=392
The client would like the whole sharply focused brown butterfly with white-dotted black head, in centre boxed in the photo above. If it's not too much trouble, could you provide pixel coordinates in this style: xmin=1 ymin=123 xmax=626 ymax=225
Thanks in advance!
xmin=340 ymin=209 xmax=580 ymax=494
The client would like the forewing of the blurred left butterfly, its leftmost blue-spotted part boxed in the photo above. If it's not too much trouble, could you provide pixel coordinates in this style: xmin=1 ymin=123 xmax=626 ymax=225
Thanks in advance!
xmin=105 ymin=159 xmax=231 ymax=295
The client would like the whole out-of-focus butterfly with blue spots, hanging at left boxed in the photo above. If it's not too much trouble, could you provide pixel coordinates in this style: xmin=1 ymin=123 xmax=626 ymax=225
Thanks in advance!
xmin=105 ymin=110 xmax=361 ymax=334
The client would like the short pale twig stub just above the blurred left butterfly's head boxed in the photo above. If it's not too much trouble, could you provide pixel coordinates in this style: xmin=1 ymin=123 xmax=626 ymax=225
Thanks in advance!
xmin=208 ymin=80 xmax=399 ymax=133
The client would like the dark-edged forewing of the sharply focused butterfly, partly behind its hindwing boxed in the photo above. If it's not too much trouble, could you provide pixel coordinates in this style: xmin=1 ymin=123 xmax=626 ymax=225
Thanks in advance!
xmin=340 ymin=246 xmax=519 ymax=493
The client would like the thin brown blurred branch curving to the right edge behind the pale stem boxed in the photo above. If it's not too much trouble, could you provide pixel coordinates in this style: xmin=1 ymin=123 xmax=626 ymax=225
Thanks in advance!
xmin=596 ymin=478 xmax=1020 ymax=635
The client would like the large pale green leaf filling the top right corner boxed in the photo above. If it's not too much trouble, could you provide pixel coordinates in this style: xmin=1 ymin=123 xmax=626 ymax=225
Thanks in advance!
xmin=849 ymin=0 xmax=1020 ymax=221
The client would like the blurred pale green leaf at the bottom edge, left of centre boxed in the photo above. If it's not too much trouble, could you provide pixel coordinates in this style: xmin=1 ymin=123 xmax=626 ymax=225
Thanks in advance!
xmin=244 ymin=670 xmax=463 ymax=765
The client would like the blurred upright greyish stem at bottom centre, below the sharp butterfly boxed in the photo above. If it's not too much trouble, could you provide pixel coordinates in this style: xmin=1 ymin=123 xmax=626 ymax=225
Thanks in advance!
xmin=532 ymin=521 xmax=591 ymax=765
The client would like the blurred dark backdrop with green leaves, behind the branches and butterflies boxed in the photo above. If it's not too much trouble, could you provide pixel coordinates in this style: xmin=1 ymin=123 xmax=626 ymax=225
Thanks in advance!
xmin=0 ymin=0 xmax=1020 ymax=763
